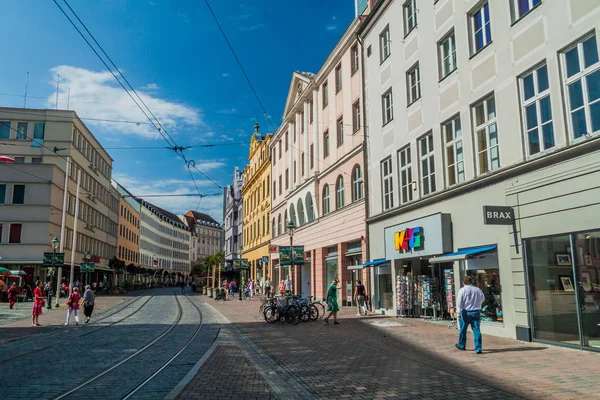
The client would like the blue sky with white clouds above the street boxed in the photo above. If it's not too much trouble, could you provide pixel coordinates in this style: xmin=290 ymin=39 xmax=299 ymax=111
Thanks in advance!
xmin=0 ymin=0 xmax=354 ymax=221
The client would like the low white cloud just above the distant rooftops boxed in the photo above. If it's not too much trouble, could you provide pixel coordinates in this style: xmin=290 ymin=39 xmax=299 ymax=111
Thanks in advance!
xmin=113 ymin=173 xmax=223 ymax=221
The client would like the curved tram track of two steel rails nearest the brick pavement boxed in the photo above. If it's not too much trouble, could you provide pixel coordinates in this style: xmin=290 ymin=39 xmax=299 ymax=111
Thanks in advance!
xmin=55 ymin=294 xmax=203 ymax=400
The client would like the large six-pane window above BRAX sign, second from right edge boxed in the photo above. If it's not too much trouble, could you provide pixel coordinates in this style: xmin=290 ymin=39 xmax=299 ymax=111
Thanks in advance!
xmin=521 ymin=64 xmax=554 ymax=156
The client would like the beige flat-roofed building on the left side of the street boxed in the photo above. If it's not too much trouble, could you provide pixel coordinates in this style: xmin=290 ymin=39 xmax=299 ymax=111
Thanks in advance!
xmin=0 ymin=108 xmax=119 ymax=279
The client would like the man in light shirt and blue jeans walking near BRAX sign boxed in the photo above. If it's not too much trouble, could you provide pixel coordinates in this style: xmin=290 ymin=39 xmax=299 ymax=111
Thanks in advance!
xmin=454 ymin=275 xmax=484 ymax=354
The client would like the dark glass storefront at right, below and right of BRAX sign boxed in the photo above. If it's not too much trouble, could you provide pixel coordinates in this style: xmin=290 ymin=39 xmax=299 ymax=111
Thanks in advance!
xmin=525 ymin=231 xmax=600 ymax=348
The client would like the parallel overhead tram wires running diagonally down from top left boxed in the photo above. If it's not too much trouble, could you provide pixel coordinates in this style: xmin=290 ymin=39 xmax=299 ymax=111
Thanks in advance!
xmin=53 ymin=0 xmax=223 ymax=195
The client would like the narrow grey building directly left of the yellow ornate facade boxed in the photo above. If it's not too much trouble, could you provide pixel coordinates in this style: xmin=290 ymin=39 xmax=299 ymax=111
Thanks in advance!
xmin=223 ymin=167 xmax=244 ymax=269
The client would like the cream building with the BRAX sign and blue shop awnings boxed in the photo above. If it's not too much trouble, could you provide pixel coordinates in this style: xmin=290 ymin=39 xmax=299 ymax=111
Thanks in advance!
xmin=359 ymin=0 xmax=600 ymax=348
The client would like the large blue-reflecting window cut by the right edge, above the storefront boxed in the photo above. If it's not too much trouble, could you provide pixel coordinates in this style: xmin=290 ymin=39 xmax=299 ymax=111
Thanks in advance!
xmin=561 ymin=35 xmax=600 ymax=139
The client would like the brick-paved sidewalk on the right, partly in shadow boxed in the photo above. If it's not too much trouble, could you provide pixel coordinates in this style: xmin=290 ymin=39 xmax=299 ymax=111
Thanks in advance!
xmin=200 ymin=296 xmax=600 ymax=399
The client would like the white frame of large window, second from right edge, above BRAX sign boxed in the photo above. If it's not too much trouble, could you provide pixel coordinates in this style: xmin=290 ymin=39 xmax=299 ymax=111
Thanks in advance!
xmin=519 ymin=63 xmax=556 ymax=157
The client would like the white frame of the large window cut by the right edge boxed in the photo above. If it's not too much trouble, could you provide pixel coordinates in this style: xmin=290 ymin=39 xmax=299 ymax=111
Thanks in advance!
xmin=560 ymin=32 xmax=600 ymax=142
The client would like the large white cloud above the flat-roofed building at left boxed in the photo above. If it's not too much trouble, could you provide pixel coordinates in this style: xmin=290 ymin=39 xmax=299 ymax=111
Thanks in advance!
xmin=46 ymin=65 xmax=202 ymax=138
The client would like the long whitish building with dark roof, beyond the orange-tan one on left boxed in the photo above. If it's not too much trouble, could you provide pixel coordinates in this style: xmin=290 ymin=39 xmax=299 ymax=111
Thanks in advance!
xmin=136 ymin=199 xmax=190 ymax=279
